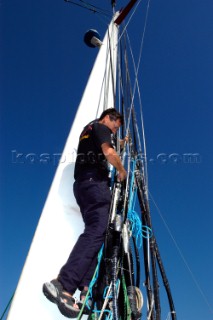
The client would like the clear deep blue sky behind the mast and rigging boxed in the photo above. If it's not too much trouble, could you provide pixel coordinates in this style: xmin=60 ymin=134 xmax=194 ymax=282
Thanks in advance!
xmin=0 ymin=0 xmax=213 ymax=320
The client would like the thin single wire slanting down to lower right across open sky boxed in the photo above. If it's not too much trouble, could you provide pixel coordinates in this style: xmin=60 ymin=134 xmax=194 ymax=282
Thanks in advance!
xmin=149 ymin=192 xmax=213 ymax=314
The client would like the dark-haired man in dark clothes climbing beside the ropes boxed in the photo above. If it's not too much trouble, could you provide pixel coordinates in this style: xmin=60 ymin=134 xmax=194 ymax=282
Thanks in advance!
xmin=43 ymin=108 xmax=127 ymax=318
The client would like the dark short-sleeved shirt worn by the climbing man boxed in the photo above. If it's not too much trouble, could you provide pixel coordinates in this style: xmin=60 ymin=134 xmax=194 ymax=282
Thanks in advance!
xmin=74 ymin=121 xmax=113 ymax=179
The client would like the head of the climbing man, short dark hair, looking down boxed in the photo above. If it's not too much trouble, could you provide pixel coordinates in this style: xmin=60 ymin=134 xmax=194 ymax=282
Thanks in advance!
xmin=99 ymin=108 xmax=123 ymax=134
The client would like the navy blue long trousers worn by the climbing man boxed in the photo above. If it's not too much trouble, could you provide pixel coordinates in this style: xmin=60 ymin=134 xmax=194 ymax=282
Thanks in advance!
xmin=58 ymin=177 xmax=111 ymax=294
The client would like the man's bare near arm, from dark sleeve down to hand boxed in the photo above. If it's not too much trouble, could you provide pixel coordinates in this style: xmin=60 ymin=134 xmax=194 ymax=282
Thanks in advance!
xmin=101 ymin=142 xmax=127 ymax=181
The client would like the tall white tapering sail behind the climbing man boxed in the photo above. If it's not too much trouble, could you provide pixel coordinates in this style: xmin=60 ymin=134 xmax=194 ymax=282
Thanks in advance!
xmin=7 ymin=15 xmax=117 ymax=320
